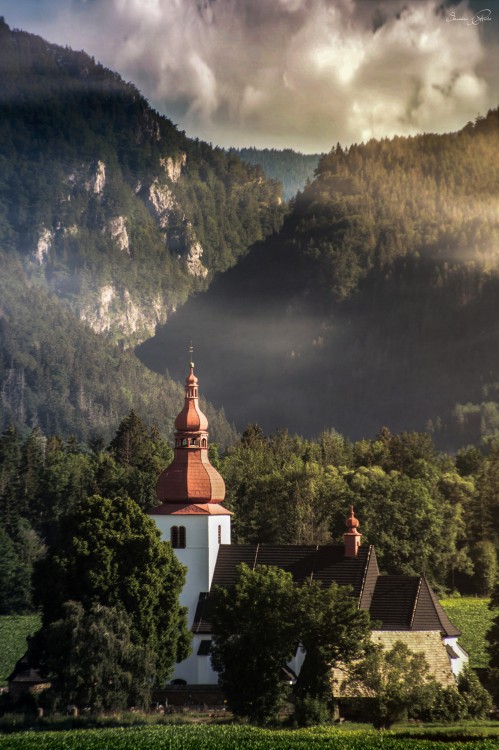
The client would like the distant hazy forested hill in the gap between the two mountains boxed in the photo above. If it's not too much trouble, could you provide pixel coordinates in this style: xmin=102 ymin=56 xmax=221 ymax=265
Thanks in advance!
xmin=229 ymin=148 xmax=321 ymax=201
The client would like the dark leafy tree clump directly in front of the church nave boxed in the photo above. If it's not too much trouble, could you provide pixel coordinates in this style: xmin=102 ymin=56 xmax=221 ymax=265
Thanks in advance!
xmin=209 ymin=563 xmax=370 ymax=723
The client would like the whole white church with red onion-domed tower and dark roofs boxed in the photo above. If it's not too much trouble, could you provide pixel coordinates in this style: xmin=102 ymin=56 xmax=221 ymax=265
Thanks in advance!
xmin=149 ymin=362 xmax=468 ymax=686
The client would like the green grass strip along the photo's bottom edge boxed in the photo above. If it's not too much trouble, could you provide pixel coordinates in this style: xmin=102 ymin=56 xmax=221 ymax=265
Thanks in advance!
xmin=0 ymin=725 xmax=498 ymax=750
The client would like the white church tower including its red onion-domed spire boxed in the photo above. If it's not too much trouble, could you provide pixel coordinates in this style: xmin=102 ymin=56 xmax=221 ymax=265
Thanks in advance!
xmin=149 ymin=347 xmax=232 ymax=683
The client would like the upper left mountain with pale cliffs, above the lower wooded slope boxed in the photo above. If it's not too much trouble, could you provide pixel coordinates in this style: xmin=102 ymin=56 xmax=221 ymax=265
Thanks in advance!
xmin=0 ymin=17 xmax=282 ymax=346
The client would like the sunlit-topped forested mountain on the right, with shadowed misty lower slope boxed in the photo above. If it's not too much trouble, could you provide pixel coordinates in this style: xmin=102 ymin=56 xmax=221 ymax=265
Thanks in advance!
xmin=140 ymin=110 xmax=499 ymax=449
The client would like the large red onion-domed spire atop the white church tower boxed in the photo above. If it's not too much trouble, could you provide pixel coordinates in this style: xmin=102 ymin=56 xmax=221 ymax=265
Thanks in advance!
xmin=156 ymin=362 xmax=227 ymax=512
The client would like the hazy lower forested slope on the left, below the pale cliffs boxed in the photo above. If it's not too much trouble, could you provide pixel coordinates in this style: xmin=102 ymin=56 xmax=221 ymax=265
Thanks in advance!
xmin=0 ymin=257 xmax=235 ymax=446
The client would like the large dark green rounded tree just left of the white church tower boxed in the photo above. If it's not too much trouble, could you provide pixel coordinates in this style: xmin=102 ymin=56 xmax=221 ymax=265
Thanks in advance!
xmin=34 ymin=496 xmax=189 ymax=681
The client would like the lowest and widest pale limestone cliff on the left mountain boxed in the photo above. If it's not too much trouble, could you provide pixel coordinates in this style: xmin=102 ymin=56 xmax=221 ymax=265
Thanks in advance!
xmin=78 ymin=284 xmax=168 ymax=348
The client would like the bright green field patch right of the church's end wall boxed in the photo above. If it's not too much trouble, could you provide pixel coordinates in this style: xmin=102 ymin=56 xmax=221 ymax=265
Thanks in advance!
xmin=440 ymin=596 xmax=493 ymax=668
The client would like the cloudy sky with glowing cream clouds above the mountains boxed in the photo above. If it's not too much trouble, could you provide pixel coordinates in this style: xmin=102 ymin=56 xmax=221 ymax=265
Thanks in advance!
xmin=0 ymin=0 xmax=499 ymax=153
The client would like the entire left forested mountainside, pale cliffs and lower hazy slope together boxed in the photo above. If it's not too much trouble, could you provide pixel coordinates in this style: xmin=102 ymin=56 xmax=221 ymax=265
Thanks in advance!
xmin=0 ymin=19 xmax=283 ymax=443
